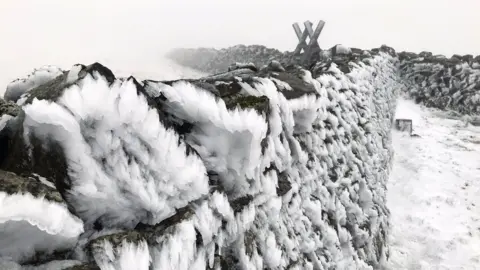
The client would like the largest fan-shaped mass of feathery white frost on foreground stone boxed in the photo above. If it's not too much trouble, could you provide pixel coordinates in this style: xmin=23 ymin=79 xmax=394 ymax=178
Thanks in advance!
xmin=24 ymin=75 xmax=208 ymax=228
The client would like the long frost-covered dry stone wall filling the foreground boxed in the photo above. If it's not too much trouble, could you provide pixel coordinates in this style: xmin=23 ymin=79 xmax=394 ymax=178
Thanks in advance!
xmin=0 ymin=47 xmax=403 ymax=269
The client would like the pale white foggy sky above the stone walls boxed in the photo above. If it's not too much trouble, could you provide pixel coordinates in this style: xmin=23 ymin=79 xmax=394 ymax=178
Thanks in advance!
xmin=0 ymin=0 xmax=480 ymax=93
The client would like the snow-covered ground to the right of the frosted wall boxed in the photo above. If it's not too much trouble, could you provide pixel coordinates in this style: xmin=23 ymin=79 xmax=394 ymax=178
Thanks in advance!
xmin=388 ymin=100 xmax=480 ymax=270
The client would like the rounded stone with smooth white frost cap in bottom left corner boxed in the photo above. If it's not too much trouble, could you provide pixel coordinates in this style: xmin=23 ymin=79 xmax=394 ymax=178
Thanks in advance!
xmin=0 ymin=170 xmax=83 ymax=262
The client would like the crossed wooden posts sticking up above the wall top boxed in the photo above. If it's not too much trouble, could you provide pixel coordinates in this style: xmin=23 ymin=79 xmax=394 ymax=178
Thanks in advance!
xmin=292 ymin=21 xmax=325 ymax=61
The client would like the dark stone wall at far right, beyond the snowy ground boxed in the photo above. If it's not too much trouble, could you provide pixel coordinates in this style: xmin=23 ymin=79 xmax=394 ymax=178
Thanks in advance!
xmin=399 ymin=52 xmax=480 ymax=114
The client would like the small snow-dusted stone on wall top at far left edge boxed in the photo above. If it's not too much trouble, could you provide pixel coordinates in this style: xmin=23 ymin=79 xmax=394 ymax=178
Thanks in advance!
xmin=4 ymin=66 xmax=63 ymax=102
